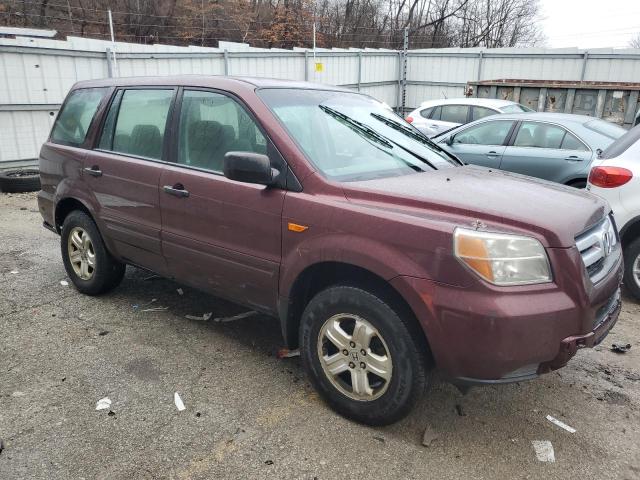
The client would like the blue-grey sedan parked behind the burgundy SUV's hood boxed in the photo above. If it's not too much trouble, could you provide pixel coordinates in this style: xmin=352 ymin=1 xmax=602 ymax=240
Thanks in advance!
xmin=433 ymin=112 xmax=626 ymax=188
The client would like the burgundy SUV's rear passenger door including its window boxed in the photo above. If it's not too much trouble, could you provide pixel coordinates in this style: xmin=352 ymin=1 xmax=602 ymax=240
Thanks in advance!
xmin=83 ymin=87 xmax=176 ymax=274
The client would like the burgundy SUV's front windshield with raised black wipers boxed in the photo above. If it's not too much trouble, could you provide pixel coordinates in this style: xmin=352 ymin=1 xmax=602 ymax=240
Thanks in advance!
xmin=258 ymin=89 xmax=459 ymax=182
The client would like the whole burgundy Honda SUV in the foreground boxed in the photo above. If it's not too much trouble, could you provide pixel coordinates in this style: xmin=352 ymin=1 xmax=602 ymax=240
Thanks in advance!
xmin=38 ymin=76 xmax=622 ymax=424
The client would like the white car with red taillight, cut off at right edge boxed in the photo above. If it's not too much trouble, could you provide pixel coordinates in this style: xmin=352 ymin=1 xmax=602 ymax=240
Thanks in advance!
xmin=587 ymin=125 xmax=640 ymax=300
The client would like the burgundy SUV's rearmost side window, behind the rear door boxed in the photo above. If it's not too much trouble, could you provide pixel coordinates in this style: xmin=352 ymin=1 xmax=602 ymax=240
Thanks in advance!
xmin=51 ymin=88 xmax=108 ymax=146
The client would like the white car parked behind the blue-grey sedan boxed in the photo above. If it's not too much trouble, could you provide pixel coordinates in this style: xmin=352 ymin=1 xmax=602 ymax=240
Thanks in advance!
xmin=405 ymin=98 xmax=533 ymax=137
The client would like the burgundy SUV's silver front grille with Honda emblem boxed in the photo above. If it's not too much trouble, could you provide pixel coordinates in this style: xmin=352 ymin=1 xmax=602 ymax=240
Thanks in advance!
xmin=576 ymin=217 xmax=618 ymax=283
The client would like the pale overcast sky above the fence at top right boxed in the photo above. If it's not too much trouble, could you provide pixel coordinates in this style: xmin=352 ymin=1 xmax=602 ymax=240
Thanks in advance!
xmin=540 ymin=0 xmax=640 ymax=48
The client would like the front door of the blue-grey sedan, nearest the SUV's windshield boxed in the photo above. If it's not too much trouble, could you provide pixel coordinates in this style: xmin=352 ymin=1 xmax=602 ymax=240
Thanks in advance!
xmin=440 ymin=120 xmax=515 ymax=168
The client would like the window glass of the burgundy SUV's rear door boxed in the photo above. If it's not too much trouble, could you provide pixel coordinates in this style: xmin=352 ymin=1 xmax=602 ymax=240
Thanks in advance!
xmin=99 ymin=89 xmax=174 ymax=159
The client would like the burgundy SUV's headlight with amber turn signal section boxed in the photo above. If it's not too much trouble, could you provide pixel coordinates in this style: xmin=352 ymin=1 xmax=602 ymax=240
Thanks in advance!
xmin=453 ymin=228 xmax=551 ymax=286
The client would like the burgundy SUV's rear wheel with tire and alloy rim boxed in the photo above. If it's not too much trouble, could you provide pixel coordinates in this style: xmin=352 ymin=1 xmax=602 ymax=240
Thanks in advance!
xmin=60 ymin=210 xmax=126 ymax=295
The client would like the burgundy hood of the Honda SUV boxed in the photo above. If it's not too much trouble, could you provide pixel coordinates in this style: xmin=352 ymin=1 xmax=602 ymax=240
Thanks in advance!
xmin=344 ymin=165 xmax=610 ymax=248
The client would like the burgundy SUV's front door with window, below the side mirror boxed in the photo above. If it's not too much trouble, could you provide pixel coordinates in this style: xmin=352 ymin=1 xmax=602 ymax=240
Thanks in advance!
xmin=160 ymin=89 xmax=286 ymax=312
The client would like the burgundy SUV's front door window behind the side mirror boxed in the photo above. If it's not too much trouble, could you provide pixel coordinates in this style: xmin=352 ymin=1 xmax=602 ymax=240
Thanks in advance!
xmin=178 ymin=90 xmax=267 ymax=172
